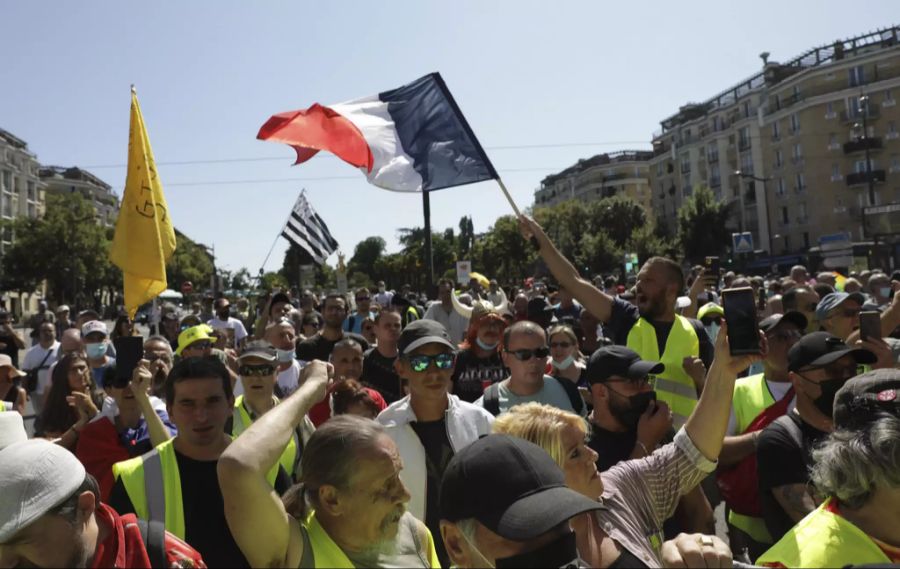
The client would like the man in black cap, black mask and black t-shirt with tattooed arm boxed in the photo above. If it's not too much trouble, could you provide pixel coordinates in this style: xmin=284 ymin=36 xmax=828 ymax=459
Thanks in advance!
xmin=756 ymin=332 xmax=876 ymax=542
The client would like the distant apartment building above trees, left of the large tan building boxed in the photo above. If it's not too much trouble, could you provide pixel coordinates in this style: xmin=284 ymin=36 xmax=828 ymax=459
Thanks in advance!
xmin=534 ymin=150 xmax=653 ymax=213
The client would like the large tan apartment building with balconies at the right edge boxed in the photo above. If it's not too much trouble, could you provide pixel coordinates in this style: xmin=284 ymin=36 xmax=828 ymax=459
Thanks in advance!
xmin=648 ymin=27 xmax=900 ymax=264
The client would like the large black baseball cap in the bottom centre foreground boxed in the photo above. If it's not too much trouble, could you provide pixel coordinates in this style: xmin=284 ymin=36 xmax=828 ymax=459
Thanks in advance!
xmin=440 ymin=434 xmax=603 ymax=542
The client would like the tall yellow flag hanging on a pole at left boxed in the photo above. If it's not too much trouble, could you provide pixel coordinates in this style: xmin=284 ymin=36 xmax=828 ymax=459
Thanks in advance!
xmin=109 ymin=88 xmax=175 ymax=318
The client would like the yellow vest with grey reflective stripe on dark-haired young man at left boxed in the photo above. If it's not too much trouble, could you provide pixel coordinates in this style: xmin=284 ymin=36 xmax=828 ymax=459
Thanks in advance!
xmin=113 ymin=439 xmax=279 ymax=539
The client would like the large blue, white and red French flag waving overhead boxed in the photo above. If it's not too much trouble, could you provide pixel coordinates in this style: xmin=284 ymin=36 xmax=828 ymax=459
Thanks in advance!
xmin=257 ymin=73 xmax=499 ymax=192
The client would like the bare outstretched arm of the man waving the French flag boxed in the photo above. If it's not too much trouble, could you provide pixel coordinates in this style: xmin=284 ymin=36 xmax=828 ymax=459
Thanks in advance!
xmin=519 ymin=215 xmax=613 ymax=322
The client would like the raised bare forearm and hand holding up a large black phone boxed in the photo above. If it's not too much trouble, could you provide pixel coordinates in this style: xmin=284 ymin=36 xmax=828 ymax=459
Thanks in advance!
xmin=684 ymin=320 xmax=766 ymax=461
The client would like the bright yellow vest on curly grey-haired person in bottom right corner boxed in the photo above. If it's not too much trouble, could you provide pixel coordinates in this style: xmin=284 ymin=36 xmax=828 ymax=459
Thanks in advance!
xmin=756 ymin=498 xmax=891 ymax=567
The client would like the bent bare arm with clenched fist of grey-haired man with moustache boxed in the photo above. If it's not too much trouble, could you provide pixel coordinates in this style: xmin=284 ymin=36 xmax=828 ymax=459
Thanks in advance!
xmin=218 ymin=361 xmax=329 ymax=567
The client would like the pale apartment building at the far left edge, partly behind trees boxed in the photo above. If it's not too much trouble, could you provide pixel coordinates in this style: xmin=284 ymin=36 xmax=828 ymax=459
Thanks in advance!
xmin=0 ymin=129 xmax=44 ymax=315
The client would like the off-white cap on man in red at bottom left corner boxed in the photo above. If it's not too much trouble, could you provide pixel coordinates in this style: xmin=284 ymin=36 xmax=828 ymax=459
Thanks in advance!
xmin=0 ymin=439 xmax=85 ymax=543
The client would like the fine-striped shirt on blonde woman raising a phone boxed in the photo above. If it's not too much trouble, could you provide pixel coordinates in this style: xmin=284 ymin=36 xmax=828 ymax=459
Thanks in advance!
xmin=595 ymin=429 xmax=716 ymax=567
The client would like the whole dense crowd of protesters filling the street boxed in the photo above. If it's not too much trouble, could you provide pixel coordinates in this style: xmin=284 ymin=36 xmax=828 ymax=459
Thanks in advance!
xmin=0 ymin=217 xmax=900 ymax=568
